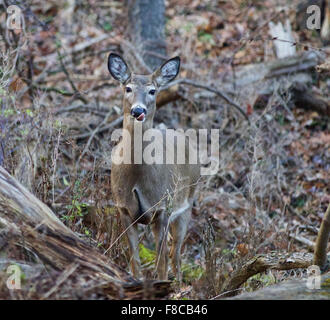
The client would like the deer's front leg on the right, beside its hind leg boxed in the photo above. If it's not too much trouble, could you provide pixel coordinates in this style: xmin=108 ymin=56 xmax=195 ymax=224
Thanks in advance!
xmin=152 ymin=211 xmax=168 ymax=280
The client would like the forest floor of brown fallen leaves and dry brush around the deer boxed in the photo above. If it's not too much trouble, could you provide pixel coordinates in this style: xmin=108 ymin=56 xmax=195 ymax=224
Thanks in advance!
xmin=0 ymin=0 xmax=330 ymax=299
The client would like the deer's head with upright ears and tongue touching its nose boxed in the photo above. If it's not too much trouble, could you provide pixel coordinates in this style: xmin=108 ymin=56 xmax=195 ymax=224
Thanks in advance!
xmin=108 ymin=53 xmax=180 ymax=124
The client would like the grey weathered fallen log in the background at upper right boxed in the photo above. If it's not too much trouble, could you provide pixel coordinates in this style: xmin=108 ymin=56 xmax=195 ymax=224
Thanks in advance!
xmin=222 ymin=50 xmax=330 ymax=115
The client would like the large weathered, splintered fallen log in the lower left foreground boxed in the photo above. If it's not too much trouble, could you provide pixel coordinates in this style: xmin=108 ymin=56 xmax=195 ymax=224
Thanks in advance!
xmin=0 ymin=167 xmax=171 ymax=299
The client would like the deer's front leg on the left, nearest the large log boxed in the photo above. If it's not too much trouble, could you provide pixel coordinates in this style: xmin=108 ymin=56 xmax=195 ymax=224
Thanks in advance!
xmin=119 ymin=209 xmax=141 ymax=279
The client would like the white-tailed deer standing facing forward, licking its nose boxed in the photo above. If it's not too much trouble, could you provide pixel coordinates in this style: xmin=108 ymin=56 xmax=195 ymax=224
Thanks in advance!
xmin=108 ymin=53 xmax=199 ymax=281
